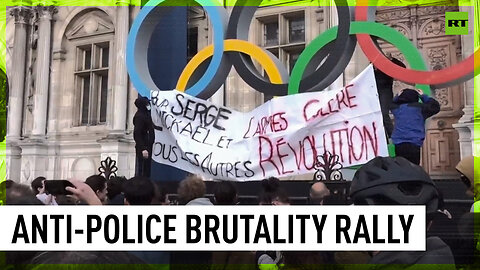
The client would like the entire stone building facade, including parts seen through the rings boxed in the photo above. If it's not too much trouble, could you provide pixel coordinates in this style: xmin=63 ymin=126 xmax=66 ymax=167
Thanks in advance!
xmin=2 ymin=0 xmax=473 ymax=182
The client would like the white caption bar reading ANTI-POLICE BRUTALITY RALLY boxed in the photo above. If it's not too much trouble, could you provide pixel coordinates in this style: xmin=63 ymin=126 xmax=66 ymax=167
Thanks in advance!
xmin=0 ymin=205 xmax=426 ymax=251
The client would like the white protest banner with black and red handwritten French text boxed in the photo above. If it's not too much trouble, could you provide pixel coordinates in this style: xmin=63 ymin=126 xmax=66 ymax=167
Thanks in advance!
xmin=152 ymin=66 xmax=388 ymax=181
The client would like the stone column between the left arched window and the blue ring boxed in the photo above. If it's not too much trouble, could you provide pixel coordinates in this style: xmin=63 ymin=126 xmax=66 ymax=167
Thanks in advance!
xmin=112 ymin=0 xmax=130 ymax=135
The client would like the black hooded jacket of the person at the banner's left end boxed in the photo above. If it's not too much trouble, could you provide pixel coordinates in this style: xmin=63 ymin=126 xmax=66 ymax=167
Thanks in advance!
xmin=133 ymin=97 xmax=155 ymax=157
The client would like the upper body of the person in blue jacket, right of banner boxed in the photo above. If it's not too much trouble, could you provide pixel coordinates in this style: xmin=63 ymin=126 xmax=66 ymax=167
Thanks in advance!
xmin=392 ymin=89 xmax=440 ymax=147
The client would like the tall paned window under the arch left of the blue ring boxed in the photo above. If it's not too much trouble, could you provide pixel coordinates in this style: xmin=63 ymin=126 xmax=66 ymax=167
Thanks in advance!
xmin=75 ymin=42 xmax=110 ymax=126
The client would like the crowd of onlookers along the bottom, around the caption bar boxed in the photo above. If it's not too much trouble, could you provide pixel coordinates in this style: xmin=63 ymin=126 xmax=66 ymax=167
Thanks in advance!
xmin=2 ymin=157 xmax=480 ymax=269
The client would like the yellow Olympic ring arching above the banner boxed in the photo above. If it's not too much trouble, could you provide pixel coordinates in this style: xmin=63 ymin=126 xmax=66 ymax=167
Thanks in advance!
xmin=176 ymin=39 xmax=285 ymax=92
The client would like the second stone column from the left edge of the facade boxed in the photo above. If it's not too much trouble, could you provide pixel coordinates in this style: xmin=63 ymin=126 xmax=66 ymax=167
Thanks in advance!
xmin=32 ymin=6 xmax=57 ymax=138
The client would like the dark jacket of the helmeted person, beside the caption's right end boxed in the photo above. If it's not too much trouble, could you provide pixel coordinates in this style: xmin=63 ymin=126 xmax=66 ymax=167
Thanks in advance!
xmin=369 ymin=237 xmax=455 ymax=270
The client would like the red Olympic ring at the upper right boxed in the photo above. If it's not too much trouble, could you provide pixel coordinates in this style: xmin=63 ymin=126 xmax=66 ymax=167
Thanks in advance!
xmin=355 ymin=0 xmax=480 ymax=86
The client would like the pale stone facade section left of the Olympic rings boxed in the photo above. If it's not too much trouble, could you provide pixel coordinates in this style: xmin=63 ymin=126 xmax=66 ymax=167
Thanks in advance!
xmin=6 ymin=3 xmax=138 ymax=182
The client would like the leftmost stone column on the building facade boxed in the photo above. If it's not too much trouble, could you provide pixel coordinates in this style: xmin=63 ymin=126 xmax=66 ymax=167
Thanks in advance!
xmin=7 ymin=7 xmax=32 ymax=140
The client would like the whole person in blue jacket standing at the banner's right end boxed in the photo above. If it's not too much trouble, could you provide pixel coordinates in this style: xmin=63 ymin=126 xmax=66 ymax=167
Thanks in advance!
xmin=391 ymin=88 xmax=440 ymax=165
